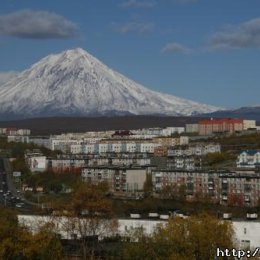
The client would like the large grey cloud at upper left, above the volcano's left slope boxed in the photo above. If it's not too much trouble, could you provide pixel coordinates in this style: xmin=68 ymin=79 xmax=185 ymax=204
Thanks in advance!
xmin=0 ymin=10 xmax=78 ymax=39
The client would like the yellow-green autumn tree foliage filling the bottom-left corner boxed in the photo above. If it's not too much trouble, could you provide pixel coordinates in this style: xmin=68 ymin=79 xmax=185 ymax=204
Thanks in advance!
xmin=0 ymin=207 xmax=62 ymax=260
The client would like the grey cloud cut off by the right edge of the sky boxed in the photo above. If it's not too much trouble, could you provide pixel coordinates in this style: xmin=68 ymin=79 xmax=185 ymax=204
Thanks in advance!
xmin=209 ymin=18 xmax=260 ymax=50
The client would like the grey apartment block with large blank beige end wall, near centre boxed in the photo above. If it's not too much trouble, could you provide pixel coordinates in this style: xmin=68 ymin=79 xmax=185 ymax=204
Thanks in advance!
xmin=81 ymin=166 xmax=147 ymax=194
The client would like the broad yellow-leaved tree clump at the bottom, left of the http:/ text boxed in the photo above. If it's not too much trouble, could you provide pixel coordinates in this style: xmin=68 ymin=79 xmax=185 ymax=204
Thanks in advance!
xmin=122 ymin=214 xmax=234 ymax=260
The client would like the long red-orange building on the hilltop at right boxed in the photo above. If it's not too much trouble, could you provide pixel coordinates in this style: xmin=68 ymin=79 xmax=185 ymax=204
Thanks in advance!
xmin=198 ymin=118 xmax=244 ymax=135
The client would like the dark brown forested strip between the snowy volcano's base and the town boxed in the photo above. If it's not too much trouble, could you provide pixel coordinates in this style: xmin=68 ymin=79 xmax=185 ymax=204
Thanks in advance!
xmin=0 ymin=116 xmax=200 ymax=135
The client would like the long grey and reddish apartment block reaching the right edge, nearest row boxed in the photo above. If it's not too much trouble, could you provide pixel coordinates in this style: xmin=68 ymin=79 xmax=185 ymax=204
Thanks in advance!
xmin=152 ymin=170 xmax=260 ymax=207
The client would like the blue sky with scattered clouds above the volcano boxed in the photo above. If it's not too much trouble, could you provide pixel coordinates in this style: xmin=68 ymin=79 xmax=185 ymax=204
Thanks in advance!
xmin=0 ymin=0 xmax=260 ymax=108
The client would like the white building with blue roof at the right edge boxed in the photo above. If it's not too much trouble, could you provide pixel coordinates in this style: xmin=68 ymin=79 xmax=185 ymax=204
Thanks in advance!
xmin=237 ymin=150 xmax=260 ymax=168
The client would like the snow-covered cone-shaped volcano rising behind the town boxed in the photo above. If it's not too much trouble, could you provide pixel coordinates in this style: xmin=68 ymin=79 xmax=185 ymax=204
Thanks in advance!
xmin=0 ymin=48 xmax=219 ymax=118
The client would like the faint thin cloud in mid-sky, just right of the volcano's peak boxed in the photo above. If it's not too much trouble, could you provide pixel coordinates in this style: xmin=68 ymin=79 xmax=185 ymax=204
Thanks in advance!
xmin=112 ymin=19 xmax=154 ymax=34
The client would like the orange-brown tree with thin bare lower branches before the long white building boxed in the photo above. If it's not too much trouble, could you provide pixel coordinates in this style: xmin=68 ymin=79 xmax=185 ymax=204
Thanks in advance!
xmin=54 ymin=183 xmax=117 ymax=259
